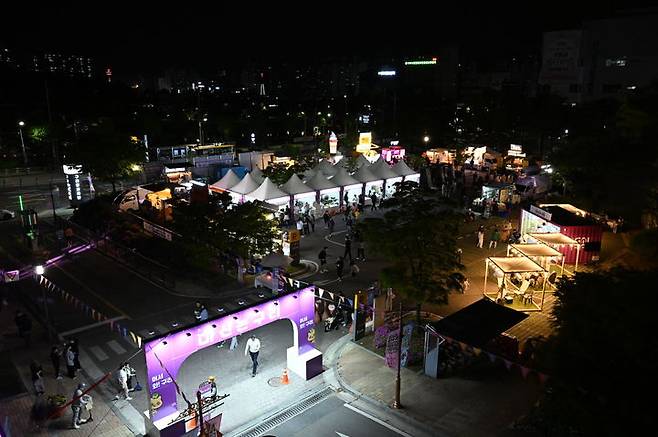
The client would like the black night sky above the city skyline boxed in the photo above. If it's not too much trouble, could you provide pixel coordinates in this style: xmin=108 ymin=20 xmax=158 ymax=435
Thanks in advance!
xmin=0 ymin=0 xmax=651 ymax=71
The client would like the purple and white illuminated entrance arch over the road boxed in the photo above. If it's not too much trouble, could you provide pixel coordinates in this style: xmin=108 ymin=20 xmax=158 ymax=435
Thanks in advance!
xmin=144 ymin=286 xmax=323 ymax=436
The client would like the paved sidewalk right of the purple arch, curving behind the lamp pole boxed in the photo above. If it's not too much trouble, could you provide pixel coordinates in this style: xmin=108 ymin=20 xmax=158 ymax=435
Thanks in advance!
xmin=335 ymin=342 xmax=540 ymax=437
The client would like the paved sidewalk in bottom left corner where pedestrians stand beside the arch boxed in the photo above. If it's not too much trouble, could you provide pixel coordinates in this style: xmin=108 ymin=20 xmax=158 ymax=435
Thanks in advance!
xmin=0 ymin=303 xmax=135 ymax=437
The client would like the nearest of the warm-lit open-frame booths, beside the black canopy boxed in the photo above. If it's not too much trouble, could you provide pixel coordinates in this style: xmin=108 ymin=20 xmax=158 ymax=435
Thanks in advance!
xmin=482 ymin=256 xmax=557 ymax=311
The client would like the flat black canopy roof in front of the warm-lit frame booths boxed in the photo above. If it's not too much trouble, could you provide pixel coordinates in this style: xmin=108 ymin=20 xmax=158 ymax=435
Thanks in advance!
xmin=432 ymin=299 xmax=528 ymax=348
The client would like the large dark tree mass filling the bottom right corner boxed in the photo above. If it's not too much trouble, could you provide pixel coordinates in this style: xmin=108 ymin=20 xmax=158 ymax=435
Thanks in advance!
xmin=538 ymin=269 xmax=658 ymax=436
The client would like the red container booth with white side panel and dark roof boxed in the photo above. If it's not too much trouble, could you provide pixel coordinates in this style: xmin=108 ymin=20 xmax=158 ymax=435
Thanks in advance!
xmin=520 ymin=205 xmax=603 ymax=264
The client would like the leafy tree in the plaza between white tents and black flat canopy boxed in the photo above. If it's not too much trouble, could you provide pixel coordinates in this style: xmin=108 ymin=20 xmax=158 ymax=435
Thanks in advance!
xmin=359 ymin=182 xmax=463 ymax=318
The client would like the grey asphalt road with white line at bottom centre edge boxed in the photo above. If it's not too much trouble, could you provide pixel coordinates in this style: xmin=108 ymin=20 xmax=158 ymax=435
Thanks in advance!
xmin=263 ymin=395 xmax=409 ymax=437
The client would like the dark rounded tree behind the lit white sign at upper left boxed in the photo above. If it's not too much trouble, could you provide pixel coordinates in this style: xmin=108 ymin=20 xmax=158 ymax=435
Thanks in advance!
xmin=67 ymin=119 xmax=144 ymax=191
